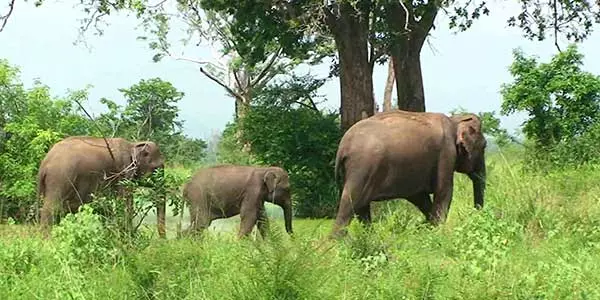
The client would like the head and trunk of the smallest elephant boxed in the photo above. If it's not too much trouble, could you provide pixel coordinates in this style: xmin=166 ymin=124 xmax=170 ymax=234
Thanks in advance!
xmin=263 ymin=167 xmax=292 ymax=234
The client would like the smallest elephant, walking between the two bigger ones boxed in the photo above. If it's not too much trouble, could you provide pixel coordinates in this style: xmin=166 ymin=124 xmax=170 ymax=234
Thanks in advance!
xmin=183 ymin=165 xmax=292 ymax=238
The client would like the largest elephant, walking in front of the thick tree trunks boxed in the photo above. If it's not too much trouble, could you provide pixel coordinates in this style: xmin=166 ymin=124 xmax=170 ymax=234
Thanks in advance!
xmin=332 ymin=110 xmax=487 ymax=237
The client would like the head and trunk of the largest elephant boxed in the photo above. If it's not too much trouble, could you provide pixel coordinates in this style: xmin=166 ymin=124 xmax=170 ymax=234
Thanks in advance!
xmin=451 ymin=114 xmax=487 ymax=209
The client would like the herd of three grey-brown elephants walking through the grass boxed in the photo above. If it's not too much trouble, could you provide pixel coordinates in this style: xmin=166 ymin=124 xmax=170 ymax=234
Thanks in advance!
xmin=38 ymin=110 xmax=487 ymax=238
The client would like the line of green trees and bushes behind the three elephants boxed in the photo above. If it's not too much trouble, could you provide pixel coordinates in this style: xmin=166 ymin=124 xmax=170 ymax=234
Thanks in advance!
xmin=0 ymin=46 xmax=600 ymax=220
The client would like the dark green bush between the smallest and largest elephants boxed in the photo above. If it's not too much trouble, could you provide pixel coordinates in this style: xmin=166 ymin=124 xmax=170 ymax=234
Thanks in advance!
xmin=238 ymin=75 xmax=341 ymax=217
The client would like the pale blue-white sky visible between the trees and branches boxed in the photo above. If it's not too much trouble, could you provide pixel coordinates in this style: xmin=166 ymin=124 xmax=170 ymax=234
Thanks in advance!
xmin=0 ymin=0 xmax=600 ymax=139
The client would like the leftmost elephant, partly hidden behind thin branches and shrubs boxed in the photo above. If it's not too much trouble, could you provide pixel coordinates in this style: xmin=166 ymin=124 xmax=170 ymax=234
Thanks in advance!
xmin=38 ymin=136 xmax=166 ymax=237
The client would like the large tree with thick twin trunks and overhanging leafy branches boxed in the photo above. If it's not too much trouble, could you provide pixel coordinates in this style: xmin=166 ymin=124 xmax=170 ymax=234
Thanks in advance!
xmin=2 ymin=0 xmax=600 ymax=129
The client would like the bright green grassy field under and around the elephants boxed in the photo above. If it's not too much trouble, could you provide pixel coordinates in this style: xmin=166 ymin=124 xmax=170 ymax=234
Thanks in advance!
xmin=0 ymin=149 xmax=600 ymax=299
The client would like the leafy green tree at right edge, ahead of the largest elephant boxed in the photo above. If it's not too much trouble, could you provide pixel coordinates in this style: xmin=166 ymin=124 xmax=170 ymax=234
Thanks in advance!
xmin=502 ymin=45 xmax=600 ymax=165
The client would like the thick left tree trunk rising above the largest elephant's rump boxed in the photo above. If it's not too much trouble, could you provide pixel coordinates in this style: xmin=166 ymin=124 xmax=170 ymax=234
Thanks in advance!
xmin=328 ymin=2 xmax=375 ymax=132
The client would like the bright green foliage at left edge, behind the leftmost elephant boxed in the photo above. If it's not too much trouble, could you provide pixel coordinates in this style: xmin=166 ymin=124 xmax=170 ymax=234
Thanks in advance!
xmin=0 ymin=61 xmax=92 ymax=222
